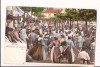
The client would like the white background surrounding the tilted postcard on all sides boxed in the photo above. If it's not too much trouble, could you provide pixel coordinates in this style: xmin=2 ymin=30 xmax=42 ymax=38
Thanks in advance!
xmin=1 ymin=0 xmax=100 ymax=66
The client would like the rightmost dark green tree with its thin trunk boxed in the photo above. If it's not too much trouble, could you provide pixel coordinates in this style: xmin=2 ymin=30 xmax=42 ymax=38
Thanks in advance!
xmin=79 ymin=9 xmax=97 ymax=31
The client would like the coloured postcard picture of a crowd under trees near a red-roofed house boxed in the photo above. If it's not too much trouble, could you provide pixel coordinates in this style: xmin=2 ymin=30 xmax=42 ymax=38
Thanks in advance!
xmin=5 ymin=6 xmax=97 ymax=65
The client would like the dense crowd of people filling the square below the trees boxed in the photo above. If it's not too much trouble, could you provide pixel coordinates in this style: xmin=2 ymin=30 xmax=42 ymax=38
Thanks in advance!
xmin=5 ymin=15 xmax=96 ymax=64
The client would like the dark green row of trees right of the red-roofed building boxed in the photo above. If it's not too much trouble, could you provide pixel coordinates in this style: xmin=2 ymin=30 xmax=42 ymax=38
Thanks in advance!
xmin=52 ymin=9 xmax=97 ymax=29
